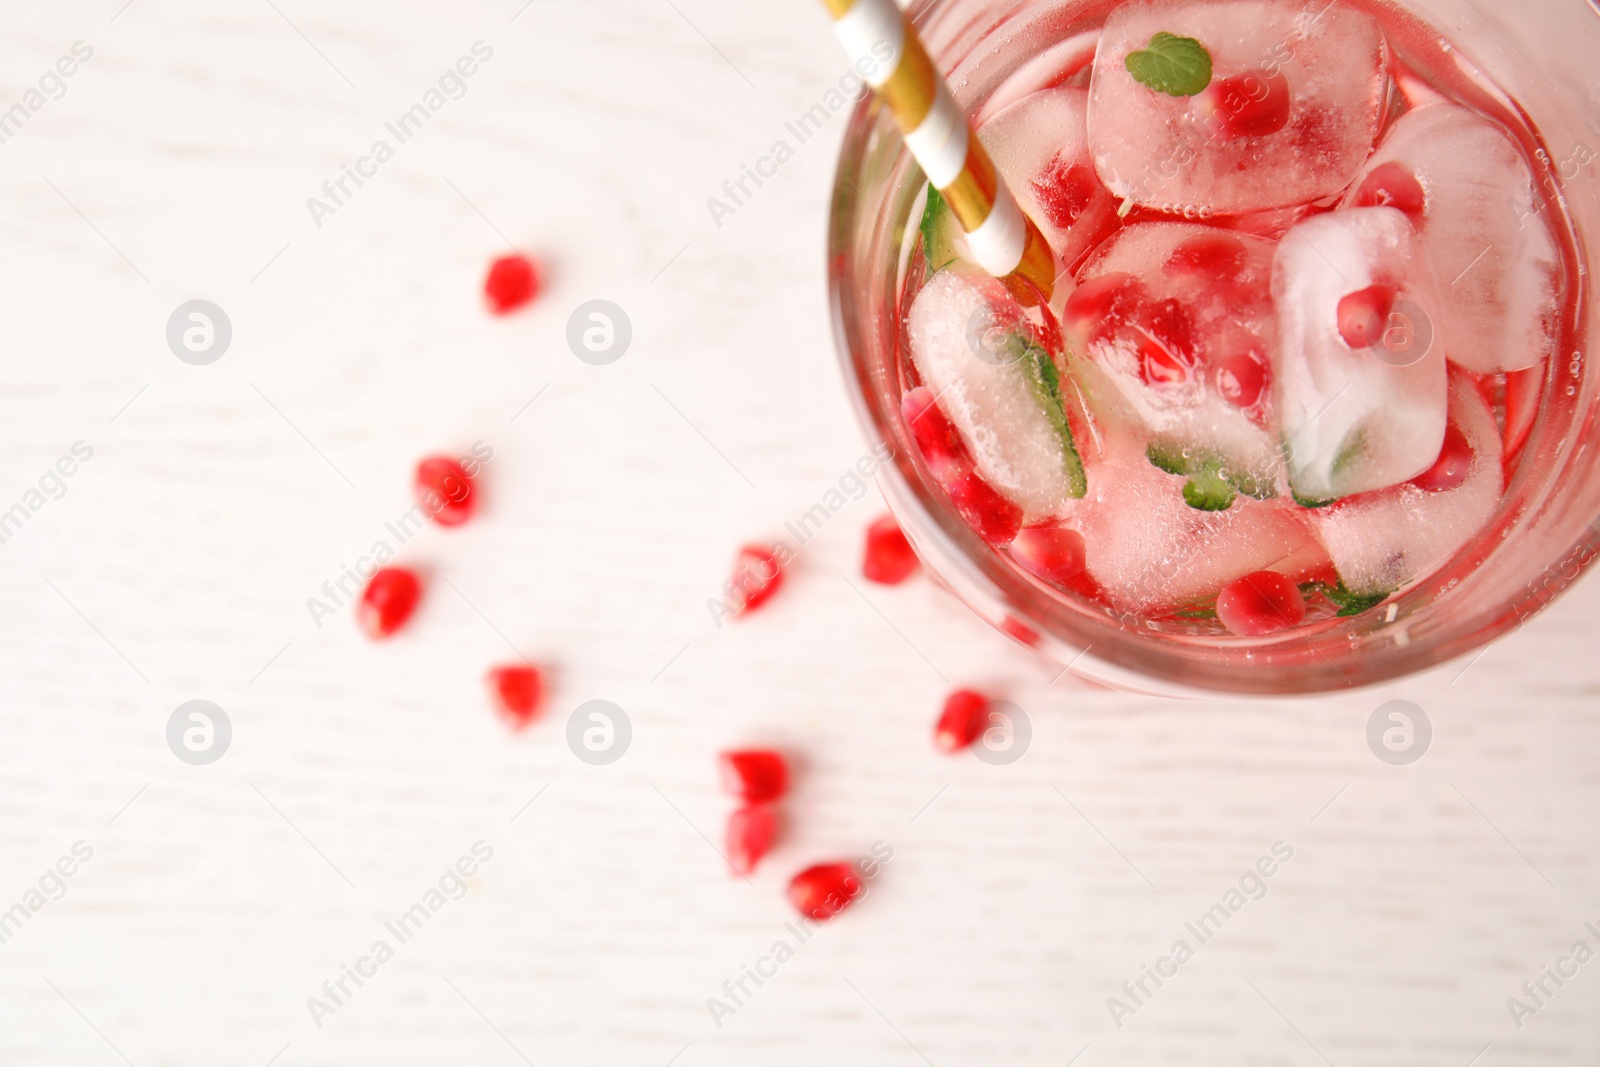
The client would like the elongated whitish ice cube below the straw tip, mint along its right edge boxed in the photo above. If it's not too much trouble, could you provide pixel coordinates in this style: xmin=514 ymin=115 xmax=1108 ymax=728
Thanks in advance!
xmin=909 ymin=264 xmax=1083 ymax=520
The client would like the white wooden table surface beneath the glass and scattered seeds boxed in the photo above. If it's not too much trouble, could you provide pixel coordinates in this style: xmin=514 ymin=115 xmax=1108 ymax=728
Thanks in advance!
xmin=0 ymin=0 xmax=1600 ymax=1067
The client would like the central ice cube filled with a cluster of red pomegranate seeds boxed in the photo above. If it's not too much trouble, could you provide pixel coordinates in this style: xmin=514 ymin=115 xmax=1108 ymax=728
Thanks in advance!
xmin=1062 ymin=222 xmax=1282 ymax=496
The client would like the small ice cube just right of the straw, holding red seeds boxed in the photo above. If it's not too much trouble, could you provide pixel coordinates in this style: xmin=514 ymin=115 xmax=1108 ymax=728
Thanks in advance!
xmin=978 ymin=88 xmax=1117 ymax=267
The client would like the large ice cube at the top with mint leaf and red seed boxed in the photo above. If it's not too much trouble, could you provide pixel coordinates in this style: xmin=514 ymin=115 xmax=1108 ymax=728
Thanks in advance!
xmin=1088 ymin=0 xmax=1389 ymax=219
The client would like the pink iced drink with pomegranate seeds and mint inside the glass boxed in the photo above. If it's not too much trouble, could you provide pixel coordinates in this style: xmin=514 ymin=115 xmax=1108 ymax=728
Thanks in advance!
xmin=876 ymin=0 xmax=1582 ymax=688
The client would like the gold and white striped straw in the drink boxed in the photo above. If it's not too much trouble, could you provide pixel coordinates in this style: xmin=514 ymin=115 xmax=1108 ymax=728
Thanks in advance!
xmin=822 ymin=0 xmax=1056 ymax=299
